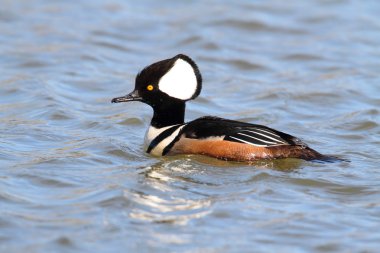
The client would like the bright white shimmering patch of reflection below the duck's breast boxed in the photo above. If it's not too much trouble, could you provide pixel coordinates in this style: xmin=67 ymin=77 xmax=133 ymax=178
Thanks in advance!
xmin=124 ymin=161 xmax=212 ymax=225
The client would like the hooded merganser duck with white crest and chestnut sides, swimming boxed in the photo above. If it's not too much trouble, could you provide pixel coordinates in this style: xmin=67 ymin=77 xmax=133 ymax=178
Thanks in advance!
xmin=112 ymin=54 xmax=325 ymax=161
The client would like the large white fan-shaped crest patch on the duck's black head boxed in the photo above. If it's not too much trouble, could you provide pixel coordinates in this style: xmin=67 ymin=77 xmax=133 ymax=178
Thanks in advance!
xmin=158 ymin=59 xmax=198 ymax=100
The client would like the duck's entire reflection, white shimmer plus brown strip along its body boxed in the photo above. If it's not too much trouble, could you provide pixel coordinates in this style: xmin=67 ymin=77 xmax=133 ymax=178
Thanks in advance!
xmin=124 ymin=156 xmax=304 ymax=225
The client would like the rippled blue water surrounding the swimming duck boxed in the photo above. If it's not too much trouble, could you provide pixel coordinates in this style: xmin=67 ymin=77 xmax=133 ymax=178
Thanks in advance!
xmin=0 ymin=0 xmax=380 ymax=252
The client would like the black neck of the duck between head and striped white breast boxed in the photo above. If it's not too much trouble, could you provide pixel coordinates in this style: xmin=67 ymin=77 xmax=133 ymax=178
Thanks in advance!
xmin=150 ymin=101 xmax=186 ymax=128
